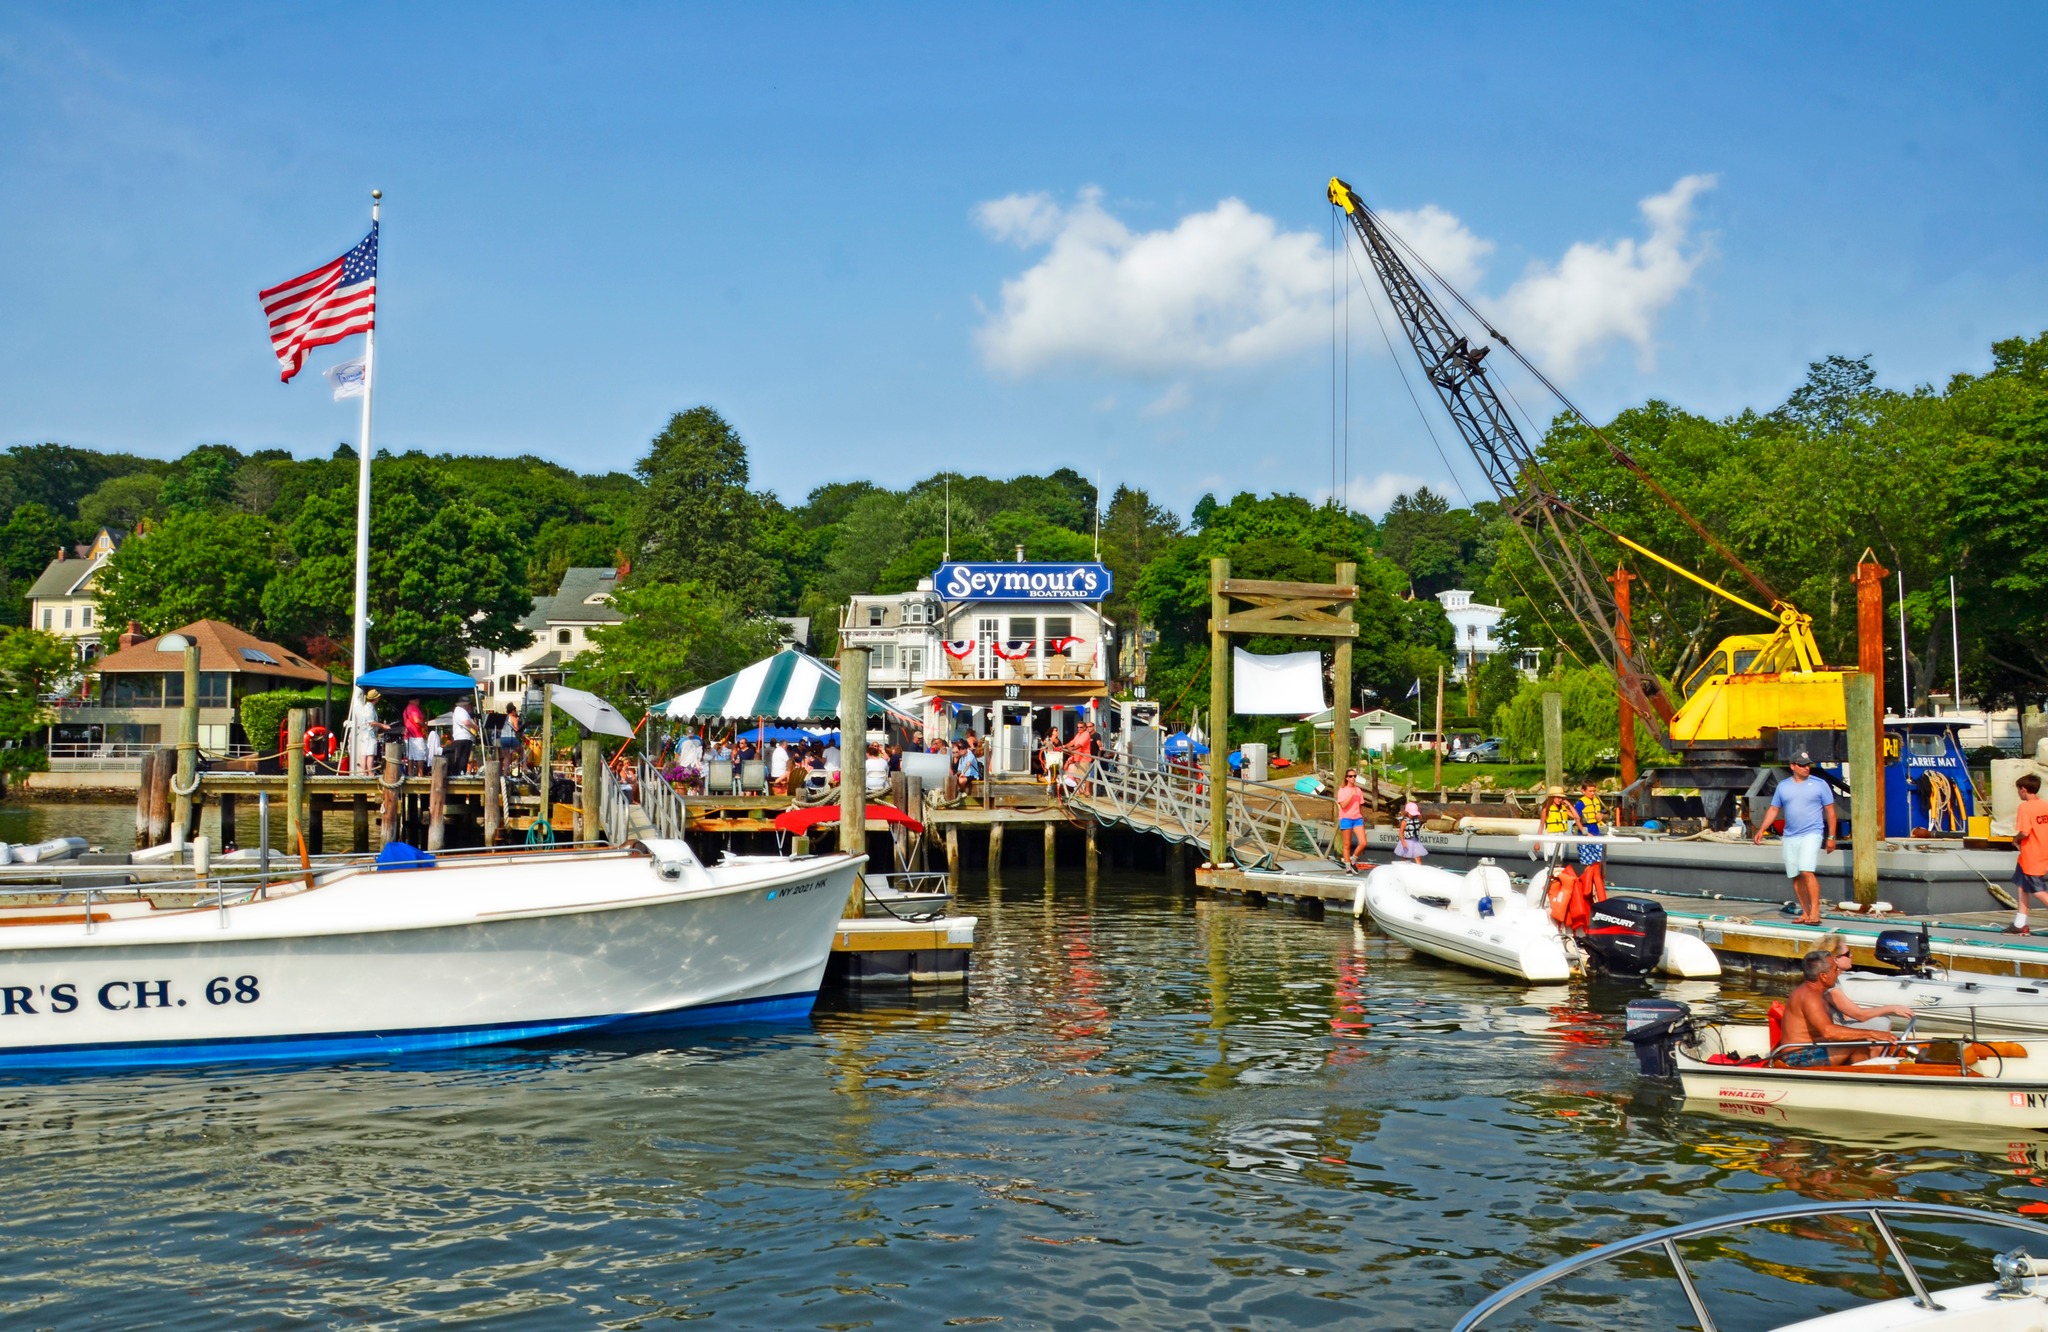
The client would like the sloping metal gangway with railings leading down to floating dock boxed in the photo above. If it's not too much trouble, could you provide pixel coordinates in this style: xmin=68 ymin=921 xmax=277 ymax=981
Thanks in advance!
xmin=1063 ymin=754 xmax=1333 ymax=869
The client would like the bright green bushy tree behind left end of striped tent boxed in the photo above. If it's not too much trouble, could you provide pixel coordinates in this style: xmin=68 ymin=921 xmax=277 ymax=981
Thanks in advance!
xmin=573 ymin=582 xmax=780 ymax=719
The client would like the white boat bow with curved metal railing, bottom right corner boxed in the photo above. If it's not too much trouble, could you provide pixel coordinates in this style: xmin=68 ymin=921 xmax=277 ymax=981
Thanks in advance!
xmin=1454 ymin=1203 xmax=2048 ymax=1332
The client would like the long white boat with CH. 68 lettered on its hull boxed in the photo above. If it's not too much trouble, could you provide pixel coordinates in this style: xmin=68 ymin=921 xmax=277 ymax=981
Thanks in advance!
xmin=0 ymin=840 xmax=862 ymax=1068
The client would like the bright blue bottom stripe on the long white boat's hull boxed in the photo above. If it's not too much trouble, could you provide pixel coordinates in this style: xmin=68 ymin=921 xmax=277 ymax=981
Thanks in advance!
xmin=0 ymin=990 xmax=817 ymax=1068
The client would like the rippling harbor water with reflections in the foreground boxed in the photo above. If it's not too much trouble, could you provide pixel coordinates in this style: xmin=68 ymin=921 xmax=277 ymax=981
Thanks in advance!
xmin=0 ymin=805 xmax=2048 ymax=1330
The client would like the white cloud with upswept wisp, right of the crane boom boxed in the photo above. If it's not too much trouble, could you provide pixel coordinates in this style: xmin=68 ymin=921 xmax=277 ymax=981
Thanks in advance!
xmin=1485 ymin=176 xmax=1716 ymax=377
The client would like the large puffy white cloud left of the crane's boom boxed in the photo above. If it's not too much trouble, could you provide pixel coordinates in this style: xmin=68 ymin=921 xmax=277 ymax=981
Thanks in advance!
xmin=975 ymin=189 xmax=1329 ymax=375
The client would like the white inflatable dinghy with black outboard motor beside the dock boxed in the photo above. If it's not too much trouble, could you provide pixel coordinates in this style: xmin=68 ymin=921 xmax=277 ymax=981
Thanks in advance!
xmin=1354 ymin=861 xmax=1720 ymax=984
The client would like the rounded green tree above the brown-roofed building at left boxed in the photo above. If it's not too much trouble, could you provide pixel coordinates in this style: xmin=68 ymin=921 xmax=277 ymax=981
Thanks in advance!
xmin=100 ymin=510 xmax=279 ymax=641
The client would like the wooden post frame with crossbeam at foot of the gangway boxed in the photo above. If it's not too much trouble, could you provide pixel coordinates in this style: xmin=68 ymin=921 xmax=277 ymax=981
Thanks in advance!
xmin=1208 ymin=557 xmax=1358 ymax=869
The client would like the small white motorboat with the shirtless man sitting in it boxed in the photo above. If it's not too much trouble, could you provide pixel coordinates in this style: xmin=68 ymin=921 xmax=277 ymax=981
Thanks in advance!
xmin=1624 ymin=998 xmax=2048 ymax=1131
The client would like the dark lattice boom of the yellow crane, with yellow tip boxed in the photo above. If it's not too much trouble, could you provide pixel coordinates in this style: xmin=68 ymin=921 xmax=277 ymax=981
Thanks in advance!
xmin=1329 ymin=176 xmax=1679 ymax=746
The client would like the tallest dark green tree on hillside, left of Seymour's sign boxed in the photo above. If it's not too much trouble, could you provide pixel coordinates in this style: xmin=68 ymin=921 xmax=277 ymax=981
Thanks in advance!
xmin=633 ymin=408 xmax=772 ymax=607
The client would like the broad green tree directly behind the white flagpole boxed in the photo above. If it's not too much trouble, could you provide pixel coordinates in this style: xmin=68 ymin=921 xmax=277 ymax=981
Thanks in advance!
xmin=264 ymin=459 xmax=532 ymax=670
